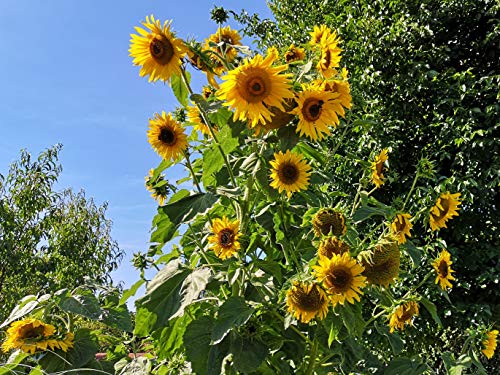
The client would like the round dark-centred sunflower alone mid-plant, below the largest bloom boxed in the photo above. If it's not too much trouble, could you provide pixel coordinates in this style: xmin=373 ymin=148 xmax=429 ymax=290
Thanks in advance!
xmin=270 ymin=150 xmax=311 ymax=198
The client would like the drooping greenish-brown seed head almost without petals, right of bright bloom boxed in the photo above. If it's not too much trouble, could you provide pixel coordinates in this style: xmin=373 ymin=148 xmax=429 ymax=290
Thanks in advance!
xmin=362 ymin=240 xmax=401 ymax=287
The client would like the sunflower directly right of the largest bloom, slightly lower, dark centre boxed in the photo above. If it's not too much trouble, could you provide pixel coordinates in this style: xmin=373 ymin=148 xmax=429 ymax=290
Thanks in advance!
xmin=291 ymin=85 xmax=344 ymax=141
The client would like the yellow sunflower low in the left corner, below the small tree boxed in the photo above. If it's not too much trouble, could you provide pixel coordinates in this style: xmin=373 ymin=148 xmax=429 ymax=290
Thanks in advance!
xmin=2 ymin=318 xmax=73 ymax=354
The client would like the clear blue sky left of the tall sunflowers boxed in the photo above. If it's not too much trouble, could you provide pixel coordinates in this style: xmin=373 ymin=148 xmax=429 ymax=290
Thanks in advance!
xmin=0 ymin=0 xmax=272 ymax=286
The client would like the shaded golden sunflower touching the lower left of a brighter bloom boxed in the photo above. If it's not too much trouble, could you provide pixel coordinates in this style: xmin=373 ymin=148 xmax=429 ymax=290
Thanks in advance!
xmin=286 ymin=282 xmax=328 ymax=323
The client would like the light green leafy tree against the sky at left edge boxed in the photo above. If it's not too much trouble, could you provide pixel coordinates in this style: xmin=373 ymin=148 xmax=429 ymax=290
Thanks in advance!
xmin=0 ymin=145 xmax=122 ymax=320
